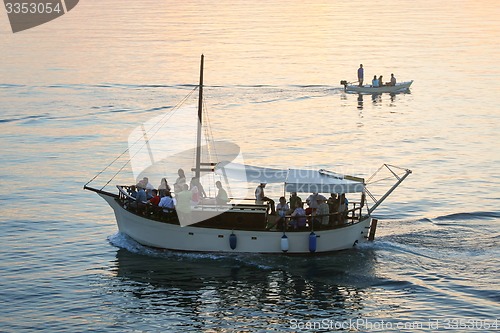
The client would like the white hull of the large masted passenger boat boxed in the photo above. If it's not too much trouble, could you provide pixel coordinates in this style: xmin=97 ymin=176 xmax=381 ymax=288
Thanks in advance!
xmin=99 ymin=193 xmax=371 ymax=254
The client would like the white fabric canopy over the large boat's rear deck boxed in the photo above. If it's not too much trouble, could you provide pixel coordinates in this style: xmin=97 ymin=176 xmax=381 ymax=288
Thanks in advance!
xmin=215 ymin=162 xmax=365 ymax=193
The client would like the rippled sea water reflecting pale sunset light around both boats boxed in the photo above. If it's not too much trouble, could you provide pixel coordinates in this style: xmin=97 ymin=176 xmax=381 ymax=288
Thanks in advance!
xmin=0 ymin=0 xmax=500 ymax=333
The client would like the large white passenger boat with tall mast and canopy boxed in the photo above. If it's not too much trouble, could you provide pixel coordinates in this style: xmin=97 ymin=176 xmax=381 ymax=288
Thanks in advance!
xmin=84 ymin=55 xmax=411 ymax=254
